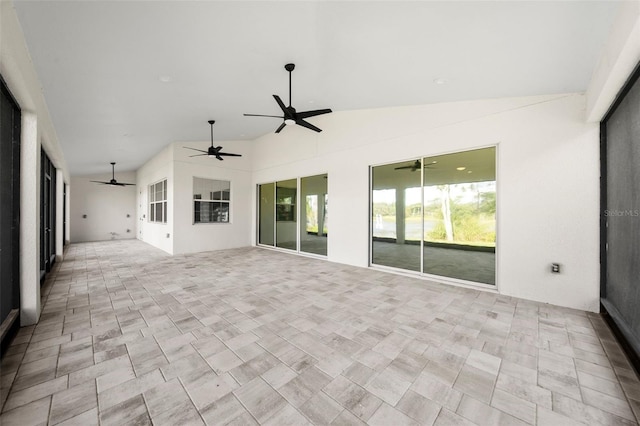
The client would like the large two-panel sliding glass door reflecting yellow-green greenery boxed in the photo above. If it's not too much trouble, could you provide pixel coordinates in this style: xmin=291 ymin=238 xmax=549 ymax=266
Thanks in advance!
xmin=371 ymin=147 xmax=496 ymax=285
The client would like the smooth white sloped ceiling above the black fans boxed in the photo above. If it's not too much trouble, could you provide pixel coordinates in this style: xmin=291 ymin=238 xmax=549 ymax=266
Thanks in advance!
xmin=15 ymin=0 xmax=620 ymax=175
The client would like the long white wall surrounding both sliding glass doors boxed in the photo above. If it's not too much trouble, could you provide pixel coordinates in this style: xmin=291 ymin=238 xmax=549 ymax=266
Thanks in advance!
xmin=251 ymin=94 xmax=599 ymax=311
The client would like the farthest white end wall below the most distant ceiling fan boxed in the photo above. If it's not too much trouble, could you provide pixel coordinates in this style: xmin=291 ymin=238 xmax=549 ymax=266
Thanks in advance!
xmin=69 ymin=172 xmax=137 ymax=243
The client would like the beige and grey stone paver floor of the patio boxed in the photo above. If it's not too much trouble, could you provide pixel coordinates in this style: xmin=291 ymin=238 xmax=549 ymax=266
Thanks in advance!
xmin=0 ymin=240 xmax=640 ymax=426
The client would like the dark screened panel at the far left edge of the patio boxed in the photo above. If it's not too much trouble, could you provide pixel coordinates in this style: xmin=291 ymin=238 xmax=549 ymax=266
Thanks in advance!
xmin=0 ymin=77 xmax=20 ymax=352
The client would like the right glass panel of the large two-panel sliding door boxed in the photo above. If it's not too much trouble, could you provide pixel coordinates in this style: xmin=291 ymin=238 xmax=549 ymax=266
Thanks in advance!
xmin=423 ymin=147 xmax=496 ymax=284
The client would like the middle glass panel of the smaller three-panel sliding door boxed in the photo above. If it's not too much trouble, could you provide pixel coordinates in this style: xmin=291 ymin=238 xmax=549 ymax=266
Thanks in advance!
xmin=276 ymin=179 xmax=298 ymax=250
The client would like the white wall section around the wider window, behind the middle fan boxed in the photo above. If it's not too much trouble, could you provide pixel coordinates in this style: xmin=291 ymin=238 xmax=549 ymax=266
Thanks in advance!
xmin=173 ymin=141 xmax=253 ymax=254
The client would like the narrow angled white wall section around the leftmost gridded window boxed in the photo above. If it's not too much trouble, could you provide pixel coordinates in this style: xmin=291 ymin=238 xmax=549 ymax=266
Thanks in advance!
xmin=137 ymin=145 xmax=174 ymax=254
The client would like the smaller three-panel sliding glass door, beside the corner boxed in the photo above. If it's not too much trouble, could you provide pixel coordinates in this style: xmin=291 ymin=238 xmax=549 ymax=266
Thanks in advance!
xmin=257 ymin=174 xmax=328 ymax=256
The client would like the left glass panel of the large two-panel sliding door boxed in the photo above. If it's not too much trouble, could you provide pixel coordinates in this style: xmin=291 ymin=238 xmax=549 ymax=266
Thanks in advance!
xmin=371 ymin=160 xmax=422 ymax=272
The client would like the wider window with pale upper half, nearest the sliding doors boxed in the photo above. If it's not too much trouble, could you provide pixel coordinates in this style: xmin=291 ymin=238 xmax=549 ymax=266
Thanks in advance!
xmin=193 ymin=177 xmax=231 ymax=223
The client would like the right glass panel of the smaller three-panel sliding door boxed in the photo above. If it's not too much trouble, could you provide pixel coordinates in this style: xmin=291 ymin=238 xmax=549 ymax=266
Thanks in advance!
xmin=300 ymin=174 xmax=328 ymax=256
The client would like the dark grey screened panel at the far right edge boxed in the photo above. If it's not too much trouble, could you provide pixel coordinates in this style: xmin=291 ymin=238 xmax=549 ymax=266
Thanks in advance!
xmin=602 ymin=62 xmax=640 ymax=362
